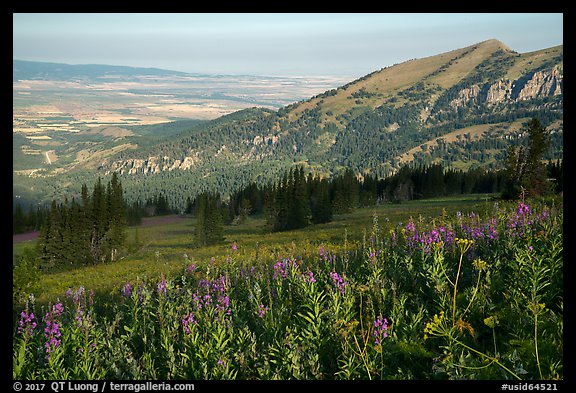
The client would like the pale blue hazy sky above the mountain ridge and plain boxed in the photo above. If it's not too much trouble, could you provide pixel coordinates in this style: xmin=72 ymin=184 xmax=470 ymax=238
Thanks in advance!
xmin=13 ymin=13 xmax=563 ymax=77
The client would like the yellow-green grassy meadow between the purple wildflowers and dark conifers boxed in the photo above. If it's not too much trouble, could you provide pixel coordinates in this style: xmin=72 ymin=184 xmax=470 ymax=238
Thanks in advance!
xmin=13 ymin=195 xmax=500 ymax=303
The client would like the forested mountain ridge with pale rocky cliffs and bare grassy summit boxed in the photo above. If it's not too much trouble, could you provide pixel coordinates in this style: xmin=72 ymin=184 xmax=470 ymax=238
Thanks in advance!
xmin=14 ymin=40 xmax=563 ymax=209
